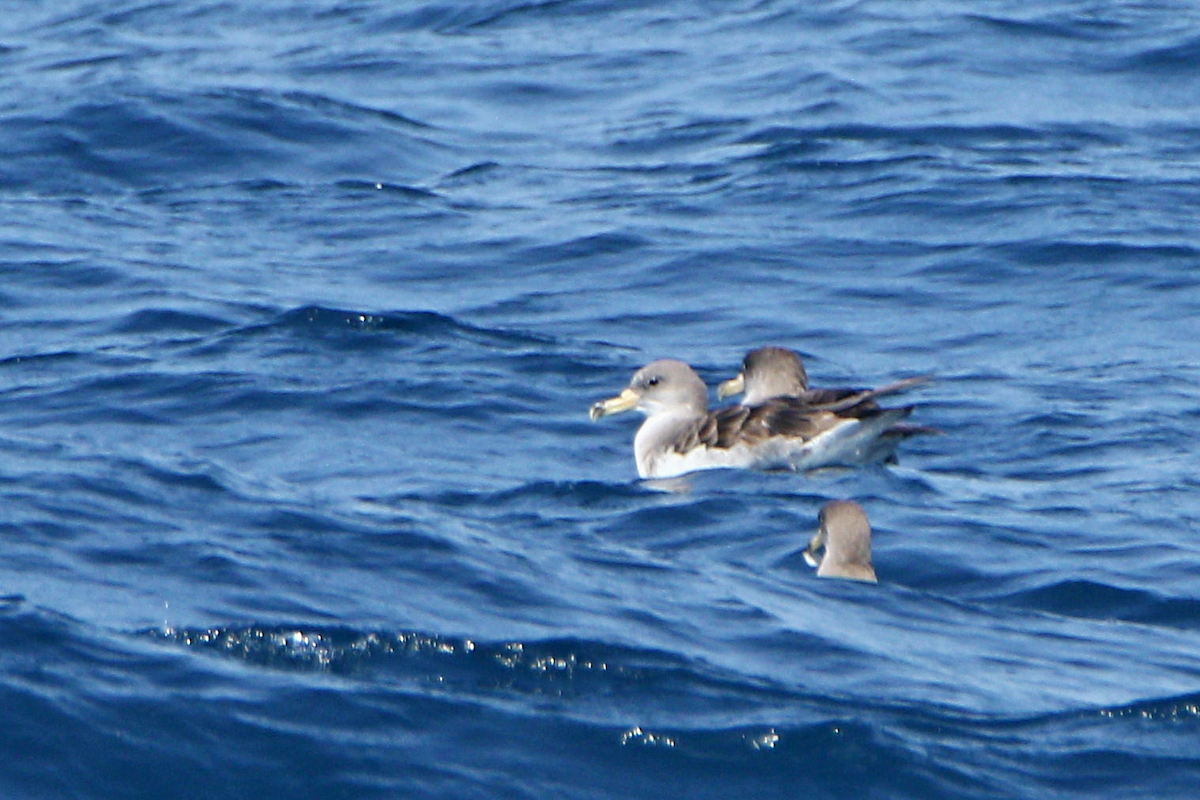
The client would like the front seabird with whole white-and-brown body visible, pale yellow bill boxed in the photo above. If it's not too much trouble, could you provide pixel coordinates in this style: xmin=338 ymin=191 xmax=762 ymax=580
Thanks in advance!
xmin=589 ymin=359 xmax=913 ymax=479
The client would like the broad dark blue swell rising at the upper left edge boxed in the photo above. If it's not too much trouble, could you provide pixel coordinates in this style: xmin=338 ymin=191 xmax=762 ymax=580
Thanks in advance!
xmin=0 ymin=88 xmax=460 ymax=194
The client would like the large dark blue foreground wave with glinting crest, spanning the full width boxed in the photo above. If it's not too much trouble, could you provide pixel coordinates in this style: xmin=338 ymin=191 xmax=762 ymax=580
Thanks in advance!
xmin=0 ymin=596 xmax=1200 ymax=800
